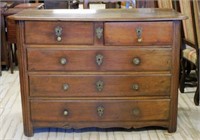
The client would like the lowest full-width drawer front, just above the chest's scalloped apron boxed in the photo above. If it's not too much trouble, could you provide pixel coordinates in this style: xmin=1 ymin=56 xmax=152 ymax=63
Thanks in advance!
xmin=31 ymin=99 xmax=170 ymax=122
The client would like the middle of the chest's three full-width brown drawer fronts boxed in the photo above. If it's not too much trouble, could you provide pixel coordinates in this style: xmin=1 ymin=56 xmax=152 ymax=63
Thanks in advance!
xmin=29 ymin=75 xmax=171 ymax=97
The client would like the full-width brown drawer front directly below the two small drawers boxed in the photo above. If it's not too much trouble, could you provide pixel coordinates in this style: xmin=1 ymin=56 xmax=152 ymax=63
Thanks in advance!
xmin=28 ymin=48 xmax=171 ymax=71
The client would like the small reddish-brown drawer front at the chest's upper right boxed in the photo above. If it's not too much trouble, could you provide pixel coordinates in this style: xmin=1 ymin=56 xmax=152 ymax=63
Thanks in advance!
xmin=104 ymin=22 xmax=173 ymax=45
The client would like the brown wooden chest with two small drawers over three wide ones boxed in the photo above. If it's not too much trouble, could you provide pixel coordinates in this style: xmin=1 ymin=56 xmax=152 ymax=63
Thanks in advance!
xmin=11 ymin=9 xmax=185 ymax=136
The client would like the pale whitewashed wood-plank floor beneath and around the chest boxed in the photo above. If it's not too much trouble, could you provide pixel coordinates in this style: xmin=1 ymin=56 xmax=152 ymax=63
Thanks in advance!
xmin=0 ymin=71 xmax=200 ymax=140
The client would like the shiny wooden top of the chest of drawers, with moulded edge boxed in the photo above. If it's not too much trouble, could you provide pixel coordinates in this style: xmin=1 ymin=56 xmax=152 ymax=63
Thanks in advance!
xmin=10 ymin=8 xmax=187 ymax=21
